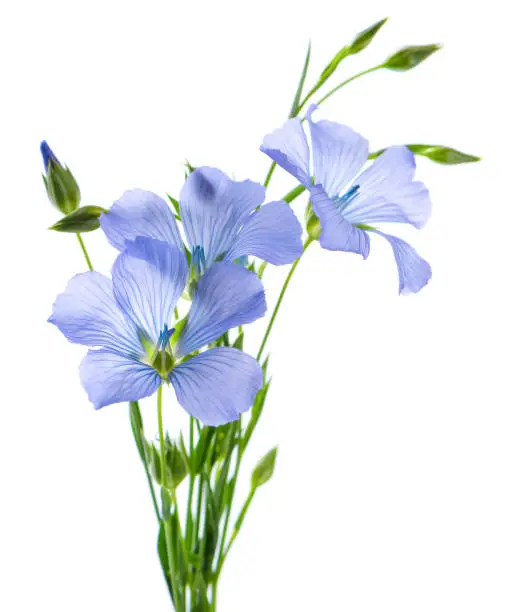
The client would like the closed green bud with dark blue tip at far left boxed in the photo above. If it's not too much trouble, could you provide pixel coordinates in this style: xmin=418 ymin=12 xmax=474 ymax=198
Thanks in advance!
xmin=41 ymin=140 xmax=80 ymax=215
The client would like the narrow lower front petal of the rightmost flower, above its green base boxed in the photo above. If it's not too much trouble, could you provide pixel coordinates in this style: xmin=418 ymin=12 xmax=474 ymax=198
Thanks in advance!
xmin=310 ymin=185 xmax=370 ymax=259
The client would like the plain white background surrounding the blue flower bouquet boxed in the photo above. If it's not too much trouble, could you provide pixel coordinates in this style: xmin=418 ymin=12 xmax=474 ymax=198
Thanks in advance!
xmin=0 ymin=0 xmax=510 ymax=612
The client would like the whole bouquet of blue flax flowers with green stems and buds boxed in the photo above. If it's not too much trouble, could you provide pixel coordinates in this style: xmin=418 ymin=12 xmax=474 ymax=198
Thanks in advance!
xmin=41 ymin=20 xmax=478 ymax=612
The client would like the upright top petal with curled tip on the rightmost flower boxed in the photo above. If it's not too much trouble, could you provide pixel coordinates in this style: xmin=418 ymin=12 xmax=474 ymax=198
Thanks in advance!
xmin=306 ymin=105 xmax=368 ymax=197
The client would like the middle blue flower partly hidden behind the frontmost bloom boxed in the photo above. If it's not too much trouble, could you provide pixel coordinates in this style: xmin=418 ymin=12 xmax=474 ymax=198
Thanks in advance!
xmin=100 ymin=167 xmax=302 ymax=274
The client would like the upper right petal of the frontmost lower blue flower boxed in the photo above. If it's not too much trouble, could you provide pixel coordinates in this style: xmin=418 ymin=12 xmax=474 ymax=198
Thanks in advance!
xmin=176 ymin=262 xmax=267 ymax=356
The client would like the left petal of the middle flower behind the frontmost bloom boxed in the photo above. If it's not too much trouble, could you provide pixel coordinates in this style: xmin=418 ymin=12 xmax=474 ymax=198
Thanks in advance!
xmin=99 ymin=189 xmax=182 ymax=251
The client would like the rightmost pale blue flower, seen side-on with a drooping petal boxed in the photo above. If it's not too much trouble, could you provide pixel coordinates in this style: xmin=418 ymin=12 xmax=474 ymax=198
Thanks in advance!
xmin=261 ymin=105 xmax=431 ymax=293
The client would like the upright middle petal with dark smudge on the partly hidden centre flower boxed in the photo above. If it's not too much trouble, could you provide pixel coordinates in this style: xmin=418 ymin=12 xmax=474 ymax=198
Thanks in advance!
xmin=180 ymin=167 xmax=265 ymax=267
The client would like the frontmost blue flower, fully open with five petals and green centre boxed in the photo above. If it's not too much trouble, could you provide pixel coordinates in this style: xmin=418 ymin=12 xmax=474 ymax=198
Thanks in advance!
xmin=50 ymin=237 xmax=266 ymax=425
